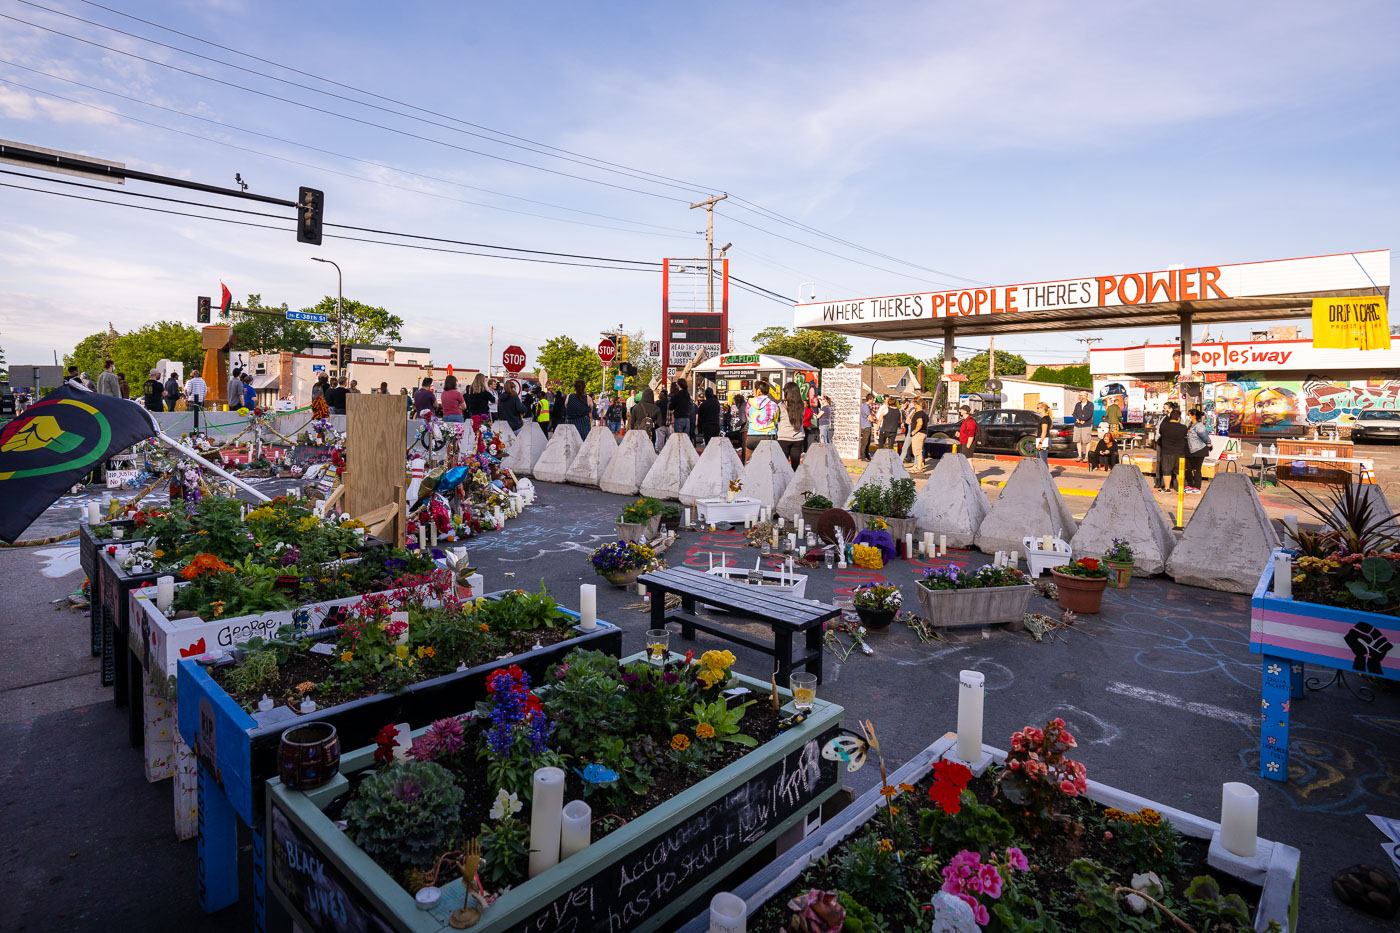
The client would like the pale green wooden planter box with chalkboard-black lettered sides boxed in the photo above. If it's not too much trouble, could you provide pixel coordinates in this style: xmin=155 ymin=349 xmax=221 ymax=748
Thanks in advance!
xmin=267 ymin=654 xmax=844 ymax=933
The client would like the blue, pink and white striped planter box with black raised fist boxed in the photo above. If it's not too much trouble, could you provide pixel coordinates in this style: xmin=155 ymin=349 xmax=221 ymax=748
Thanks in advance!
xmin=1249 ymin=548 xmax=1400 ymax=782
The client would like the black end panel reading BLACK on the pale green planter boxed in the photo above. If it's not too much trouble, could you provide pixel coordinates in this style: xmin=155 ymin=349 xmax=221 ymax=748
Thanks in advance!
xmin=269 ymin=807 xmax=393 ymax=933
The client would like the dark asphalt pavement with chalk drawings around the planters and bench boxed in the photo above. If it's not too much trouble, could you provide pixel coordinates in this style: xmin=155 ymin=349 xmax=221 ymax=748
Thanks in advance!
xmin=0 ymin=483 xmax=1400 ymax=930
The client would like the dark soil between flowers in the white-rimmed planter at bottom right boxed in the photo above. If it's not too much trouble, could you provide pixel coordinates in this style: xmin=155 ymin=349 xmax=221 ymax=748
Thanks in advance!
xmin=749 ymin=772 xmax=1260 ymax=933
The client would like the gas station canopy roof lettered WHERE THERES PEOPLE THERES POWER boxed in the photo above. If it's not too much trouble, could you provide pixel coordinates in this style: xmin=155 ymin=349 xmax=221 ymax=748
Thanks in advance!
xmin=794 ymin=249 xmax=1390 ymax=340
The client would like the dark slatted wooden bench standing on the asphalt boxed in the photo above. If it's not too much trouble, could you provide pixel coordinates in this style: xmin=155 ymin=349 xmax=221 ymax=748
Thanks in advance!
xmin=637 ymin=567 xmax=840 ymax=684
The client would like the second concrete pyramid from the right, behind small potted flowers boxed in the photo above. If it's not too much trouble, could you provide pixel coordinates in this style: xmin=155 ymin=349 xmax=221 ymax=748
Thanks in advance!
xmin=1070 ymin=464 xmax=1176 ymax=576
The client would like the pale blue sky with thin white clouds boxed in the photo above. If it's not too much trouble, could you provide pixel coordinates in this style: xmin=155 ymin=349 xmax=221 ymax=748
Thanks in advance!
xmin=0 ymin=0 xmax=1400 ymax=367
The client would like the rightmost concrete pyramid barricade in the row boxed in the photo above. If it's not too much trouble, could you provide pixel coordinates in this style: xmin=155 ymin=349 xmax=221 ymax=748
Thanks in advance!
xmin=1166 ymin=474 xmax=1278 ymax=593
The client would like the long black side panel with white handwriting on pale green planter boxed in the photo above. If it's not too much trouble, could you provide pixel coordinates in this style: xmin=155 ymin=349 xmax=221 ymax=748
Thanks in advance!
xmin=512 ymin=728 xmax=840 ymax=933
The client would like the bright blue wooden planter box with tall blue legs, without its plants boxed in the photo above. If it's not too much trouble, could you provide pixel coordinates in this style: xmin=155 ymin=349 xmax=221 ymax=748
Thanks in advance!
xmin=176 ymin=607 xmax=622 ymax=916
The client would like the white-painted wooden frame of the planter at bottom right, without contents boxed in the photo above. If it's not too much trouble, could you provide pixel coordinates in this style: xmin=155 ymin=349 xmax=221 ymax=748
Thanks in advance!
xmin=678 ymin=733 xmax=1299 ymax=933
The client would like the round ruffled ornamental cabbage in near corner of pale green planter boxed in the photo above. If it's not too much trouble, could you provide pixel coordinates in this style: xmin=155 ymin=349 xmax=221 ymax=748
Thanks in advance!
xmin=344 ymin=761 xmax=462 ymax=874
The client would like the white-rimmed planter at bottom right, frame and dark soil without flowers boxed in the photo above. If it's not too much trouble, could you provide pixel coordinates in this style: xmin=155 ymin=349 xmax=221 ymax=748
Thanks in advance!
xmin=678 ymin=733 xmax=1299 ymax=933
